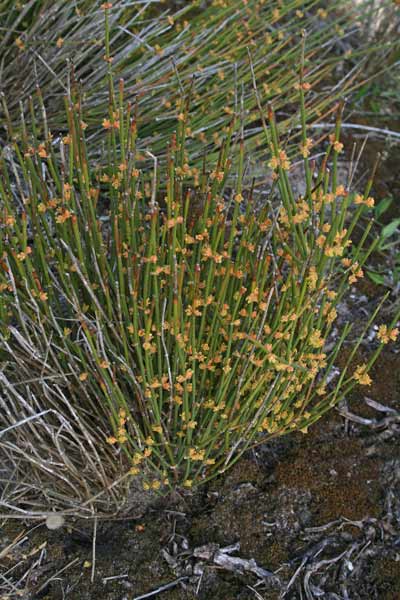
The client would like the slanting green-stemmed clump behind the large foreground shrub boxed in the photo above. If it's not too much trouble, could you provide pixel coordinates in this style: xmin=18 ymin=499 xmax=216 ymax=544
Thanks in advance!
xmin=0 ymin=0 xmax=394 ymax=159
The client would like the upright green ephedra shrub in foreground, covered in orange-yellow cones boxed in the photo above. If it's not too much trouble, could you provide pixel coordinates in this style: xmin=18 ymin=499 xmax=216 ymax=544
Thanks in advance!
xmin=0 ymin=74 xmax=397 ymax=515
